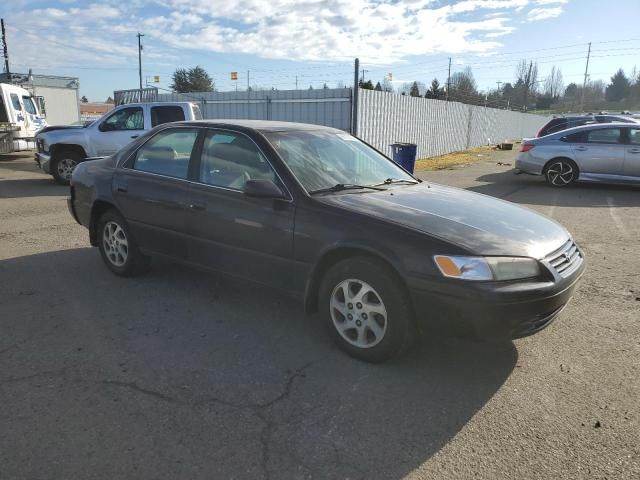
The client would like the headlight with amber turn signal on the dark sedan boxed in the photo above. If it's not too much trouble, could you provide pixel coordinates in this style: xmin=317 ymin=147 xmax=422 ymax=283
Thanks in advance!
xmin=433 ymin=255 xmax=540 ymax=280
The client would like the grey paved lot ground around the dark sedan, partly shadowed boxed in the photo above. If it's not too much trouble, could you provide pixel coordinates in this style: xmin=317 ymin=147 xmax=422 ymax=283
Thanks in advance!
xmin=0 ymin=152 xmax=640 ymax=480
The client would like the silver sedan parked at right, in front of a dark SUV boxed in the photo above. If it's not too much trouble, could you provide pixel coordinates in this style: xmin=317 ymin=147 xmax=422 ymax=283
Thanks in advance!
xmin=515 ymin=123 xmax=640 ymax=187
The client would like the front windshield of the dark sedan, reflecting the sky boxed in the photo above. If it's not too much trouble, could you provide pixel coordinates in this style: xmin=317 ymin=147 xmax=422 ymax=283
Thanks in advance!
xmin=265 ymin=130 xmax=416 ymax=192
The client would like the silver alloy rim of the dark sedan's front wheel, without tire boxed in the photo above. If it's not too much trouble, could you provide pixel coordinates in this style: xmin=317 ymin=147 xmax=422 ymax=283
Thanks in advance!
xmin=330 ymin=279 xmax=388 ymax=348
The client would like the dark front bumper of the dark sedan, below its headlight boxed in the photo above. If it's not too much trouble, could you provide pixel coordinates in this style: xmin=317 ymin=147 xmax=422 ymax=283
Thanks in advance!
xmin=410 ymin=258 xmax=585 ymax=340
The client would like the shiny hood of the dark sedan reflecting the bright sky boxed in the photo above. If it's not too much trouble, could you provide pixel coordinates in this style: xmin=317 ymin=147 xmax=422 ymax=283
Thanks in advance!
xmin=314 ymin=182 xmax=570 ymax=259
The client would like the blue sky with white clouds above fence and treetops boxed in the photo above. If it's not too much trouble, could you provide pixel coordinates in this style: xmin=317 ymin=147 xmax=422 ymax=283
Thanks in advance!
xmin=0 ymin=0 xmax=640 ymax=101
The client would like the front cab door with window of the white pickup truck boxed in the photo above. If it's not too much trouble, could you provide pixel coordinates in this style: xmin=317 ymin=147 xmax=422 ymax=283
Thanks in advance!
xmin=87 ymin=106 xmax=147 ymax=157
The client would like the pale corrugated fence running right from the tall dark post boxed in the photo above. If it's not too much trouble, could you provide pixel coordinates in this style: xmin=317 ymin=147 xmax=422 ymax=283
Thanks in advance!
xmin=357 ymin=89 xmax=549 ymax=158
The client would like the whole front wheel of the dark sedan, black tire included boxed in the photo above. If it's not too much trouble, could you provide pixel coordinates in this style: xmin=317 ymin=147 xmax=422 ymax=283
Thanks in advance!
xmin=319 ymin=257 xmax=415 ymax=363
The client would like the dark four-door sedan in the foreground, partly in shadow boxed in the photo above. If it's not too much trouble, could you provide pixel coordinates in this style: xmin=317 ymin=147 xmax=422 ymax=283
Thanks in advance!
xmin=69 ymin=120 xmax=584 ymax=361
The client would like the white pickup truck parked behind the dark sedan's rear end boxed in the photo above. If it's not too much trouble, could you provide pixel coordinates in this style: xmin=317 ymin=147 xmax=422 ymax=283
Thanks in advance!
xmin=36 ymin=102 xmax=202 ymax=185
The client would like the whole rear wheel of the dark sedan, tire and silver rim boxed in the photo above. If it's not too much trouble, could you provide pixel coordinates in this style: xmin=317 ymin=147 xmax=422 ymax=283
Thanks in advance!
xmin=97 ymin=210 xmax=151 ymax=277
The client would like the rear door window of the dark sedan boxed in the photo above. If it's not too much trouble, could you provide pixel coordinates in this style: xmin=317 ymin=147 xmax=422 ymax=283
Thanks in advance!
xmin=132 ymin=128 xmax=198 ymax=179
